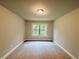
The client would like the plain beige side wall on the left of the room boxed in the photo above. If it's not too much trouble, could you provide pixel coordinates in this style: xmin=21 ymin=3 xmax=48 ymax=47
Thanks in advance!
xmin=0 ymin=5 xmax=24 ymax=58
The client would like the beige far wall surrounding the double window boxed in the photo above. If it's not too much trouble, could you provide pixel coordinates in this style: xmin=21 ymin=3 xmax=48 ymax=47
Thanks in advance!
xmin=25 ymin=21 xmax=53 ymax=40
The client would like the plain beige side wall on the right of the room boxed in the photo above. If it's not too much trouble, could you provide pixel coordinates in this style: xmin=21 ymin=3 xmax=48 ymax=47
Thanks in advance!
xmin=54 ymin=8 xmax=79 ymax=59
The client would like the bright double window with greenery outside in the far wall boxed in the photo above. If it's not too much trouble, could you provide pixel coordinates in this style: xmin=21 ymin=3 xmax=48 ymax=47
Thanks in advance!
xmin=32 ymin=23 xmax=47 ymax=37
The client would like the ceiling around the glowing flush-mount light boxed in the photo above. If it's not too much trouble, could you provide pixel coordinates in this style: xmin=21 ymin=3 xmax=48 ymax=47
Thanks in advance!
xmin=0 ymin=0 xmax=79 ymax=20
